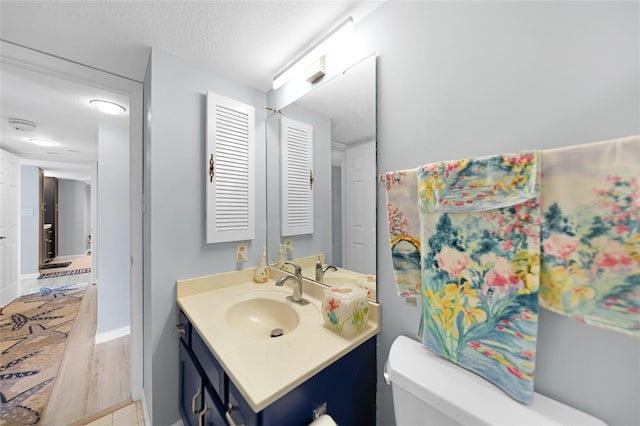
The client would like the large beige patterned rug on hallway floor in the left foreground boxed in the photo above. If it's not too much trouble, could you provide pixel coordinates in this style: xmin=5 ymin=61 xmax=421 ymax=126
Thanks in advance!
xmin=0 ymin=282 xmax=88 ymax=426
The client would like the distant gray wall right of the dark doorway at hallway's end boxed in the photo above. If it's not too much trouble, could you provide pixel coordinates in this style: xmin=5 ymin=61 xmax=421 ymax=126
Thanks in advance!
xmin=58 ymin=179 xmax=89 ymax=256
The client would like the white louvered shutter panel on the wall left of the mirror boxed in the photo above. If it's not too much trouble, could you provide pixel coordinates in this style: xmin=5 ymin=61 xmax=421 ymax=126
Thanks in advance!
xmin=206 ymin=92 xmax=255 ymax=243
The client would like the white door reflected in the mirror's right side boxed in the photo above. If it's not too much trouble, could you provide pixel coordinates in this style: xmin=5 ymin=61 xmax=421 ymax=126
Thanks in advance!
xmin=344 ymin=142 xmax=376 ymax=274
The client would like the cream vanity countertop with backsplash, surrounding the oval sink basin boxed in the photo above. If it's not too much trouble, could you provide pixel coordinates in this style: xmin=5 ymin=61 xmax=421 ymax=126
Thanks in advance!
xmin=176 ymin=268 xmax=380 ymax=413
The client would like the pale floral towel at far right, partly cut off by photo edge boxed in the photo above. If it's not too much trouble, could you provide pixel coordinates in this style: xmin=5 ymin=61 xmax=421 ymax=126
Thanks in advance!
xmin=540 ymin=136 xmax=640 ymax=337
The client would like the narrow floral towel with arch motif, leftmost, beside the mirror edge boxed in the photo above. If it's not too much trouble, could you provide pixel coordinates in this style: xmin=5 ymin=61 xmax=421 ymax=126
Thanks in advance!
xmin=384 ymin=169 xmax=421 ymax=297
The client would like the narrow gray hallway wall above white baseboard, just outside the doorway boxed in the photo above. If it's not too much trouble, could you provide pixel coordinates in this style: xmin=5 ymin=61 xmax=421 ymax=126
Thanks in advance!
xmin=97 ymin=122 xmax=131 ymax=334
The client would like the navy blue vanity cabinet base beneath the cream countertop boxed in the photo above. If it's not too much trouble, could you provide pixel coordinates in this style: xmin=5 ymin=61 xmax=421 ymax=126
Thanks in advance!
xmin=180 ymin=313 xmax=376 ymax=426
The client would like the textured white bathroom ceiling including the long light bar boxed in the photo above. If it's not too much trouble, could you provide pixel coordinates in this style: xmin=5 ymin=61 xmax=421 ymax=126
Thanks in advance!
xmin=0 ymin=1 xmax=382 ymax=91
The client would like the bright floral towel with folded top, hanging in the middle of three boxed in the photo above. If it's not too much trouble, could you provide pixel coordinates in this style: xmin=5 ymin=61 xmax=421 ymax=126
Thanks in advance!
xmin=417 ymin=152 xmax=540 ymax=403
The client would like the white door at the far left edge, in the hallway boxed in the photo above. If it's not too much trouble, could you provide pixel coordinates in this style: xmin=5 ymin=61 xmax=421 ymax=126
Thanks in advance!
xmin=0 ymin=150 xmax=20 ymax=306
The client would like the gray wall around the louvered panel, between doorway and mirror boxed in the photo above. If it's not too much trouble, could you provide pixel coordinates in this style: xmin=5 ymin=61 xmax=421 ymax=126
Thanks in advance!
xmin=144 ymin=49 xmax=266 ymax=426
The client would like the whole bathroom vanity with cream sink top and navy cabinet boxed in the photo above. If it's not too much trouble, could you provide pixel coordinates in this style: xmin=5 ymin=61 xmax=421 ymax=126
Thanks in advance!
xmin=177 ymin=269 xmax=380 ymax=426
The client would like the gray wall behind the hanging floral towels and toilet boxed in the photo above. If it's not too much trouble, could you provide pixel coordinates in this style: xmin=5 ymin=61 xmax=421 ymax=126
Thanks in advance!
xmin=356 ymin=2 xmax=640 ymax=426
